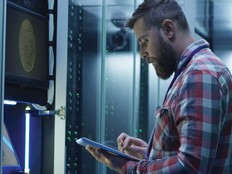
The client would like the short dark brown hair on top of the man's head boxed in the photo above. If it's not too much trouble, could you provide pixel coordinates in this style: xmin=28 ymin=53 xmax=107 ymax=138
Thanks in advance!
xmin=127 ymin=0 xmax=189 ymax=30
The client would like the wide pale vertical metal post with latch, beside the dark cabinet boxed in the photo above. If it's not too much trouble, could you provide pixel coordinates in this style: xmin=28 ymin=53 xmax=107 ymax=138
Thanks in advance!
xmin=54 ymin=0 xmax=66 ymax=174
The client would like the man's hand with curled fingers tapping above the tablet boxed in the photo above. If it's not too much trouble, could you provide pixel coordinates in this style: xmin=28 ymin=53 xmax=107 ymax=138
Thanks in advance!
xmin=117 ymin=133 xmax=148 ymax=159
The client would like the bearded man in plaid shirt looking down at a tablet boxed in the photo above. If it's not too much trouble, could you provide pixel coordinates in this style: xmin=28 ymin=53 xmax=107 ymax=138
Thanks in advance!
xmin=86 ymin=0 xmax=232 ymax=174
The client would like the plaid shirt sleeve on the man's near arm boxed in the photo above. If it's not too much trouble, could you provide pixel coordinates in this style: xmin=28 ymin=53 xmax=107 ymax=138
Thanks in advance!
xmin=121 ymin=70 xmax=223 ymax=174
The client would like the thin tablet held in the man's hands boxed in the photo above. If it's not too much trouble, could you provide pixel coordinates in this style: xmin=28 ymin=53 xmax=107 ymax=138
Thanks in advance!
xmin=76 ymin=137 xmax=139 ymax=161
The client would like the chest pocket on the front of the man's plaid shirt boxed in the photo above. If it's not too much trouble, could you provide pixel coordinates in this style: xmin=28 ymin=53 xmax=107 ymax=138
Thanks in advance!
xmin=152 ymin=108 xmax=180 ymax=158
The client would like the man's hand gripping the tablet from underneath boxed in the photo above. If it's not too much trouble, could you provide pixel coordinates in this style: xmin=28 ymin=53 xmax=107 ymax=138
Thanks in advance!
xmin=86 ymin=145 xmax=128 ymax=173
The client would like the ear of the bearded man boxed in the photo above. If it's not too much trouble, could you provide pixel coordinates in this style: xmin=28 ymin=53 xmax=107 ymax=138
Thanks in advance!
xmin=162 ymin=19 xmax=175 ymax=40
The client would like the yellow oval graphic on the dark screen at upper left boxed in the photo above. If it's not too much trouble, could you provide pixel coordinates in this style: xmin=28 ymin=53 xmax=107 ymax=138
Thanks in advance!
xmin=19 ymin=19 xmax=36 ymax=72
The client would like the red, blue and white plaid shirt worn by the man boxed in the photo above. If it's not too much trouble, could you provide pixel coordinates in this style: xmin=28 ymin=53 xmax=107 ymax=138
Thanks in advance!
xmin=124 ymin=40 xmax=232 ymax=174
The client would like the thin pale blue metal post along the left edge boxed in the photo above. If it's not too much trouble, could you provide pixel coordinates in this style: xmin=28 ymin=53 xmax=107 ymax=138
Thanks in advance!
xmin=0 ymin=0 xmax=6 ymax=173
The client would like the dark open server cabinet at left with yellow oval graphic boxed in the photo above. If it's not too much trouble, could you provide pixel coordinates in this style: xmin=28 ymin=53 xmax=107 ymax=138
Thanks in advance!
xmin=1 ymin=0 xmax=54 ymax=174
